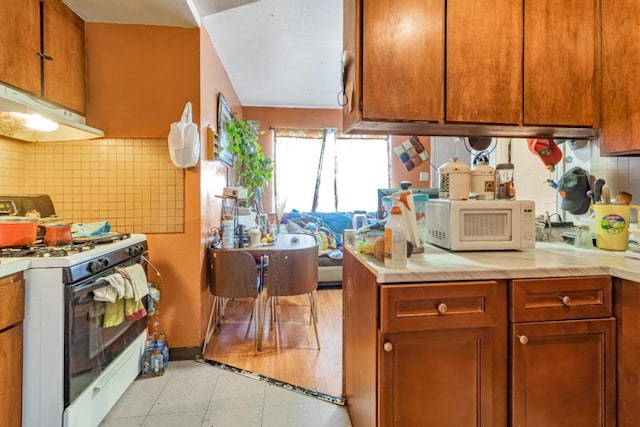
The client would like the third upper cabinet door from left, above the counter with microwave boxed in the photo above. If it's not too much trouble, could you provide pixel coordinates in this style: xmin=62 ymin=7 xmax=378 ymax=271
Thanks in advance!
xmin=524 ymin=0 xmax=600 ymax=127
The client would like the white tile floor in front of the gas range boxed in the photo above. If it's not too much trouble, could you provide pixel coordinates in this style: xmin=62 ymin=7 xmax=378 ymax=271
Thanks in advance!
xmin=101 ymin=361 xmax=351 ymax=427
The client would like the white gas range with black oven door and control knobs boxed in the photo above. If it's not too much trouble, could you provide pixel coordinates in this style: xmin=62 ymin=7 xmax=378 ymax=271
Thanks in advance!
xmin=16 ymin=234 xmax=147 ymax=427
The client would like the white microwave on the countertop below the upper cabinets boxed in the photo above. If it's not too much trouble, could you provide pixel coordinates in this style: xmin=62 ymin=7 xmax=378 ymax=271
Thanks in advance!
xmin=423 ymin=199 xmax=536 ymax=251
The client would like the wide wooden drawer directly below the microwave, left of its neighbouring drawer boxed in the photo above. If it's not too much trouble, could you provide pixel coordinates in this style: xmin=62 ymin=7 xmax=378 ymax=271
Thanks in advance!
xmin=380 ymin=280 xmax=506 ymax=333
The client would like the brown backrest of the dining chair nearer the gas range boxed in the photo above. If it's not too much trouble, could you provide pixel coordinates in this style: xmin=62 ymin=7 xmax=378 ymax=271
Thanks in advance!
xmin=208 ymin=248 xmax=261 ymax=298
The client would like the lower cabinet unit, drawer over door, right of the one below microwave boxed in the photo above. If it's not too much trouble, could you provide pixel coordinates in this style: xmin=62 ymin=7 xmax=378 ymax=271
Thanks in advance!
xmin=509 ymin=276 xmax=616 ymax=427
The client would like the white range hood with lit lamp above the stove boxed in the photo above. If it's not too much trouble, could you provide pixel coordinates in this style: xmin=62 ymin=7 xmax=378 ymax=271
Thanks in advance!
xmin=0 ymin=83 xmax=104 ymax=142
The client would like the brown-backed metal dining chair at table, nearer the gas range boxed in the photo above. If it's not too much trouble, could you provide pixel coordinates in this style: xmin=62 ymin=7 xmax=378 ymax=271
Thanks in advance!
xmin=202 ymin=248 xmax=265 ymax=354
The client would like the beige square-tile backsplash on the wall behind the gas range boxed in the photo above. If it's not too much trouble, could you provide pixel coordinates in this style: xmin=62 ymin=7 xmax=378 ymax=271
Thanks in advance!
xmin=0 ymin=138 xmax=184 ymax=234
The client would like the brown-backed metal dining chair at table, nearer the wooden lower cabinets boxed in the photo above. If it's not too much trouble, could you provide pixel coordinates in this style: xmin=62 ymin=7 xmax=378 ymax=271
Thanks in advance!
xmin=261 ymin=246 xmax=320 ymax=350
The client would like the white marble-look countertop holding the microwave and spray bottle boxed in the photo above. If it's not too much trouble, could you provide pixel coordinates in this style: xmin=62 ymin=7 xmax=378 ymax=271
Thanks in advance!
xmin=352 ymin=242 xmax=640 ymax=283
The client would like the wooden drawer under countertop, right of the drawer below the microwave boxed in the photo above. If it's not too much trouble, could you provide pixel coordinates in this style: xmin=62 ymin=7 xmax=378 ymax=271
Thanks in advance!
xmin=511 ymin=276 xmax=612 ymax=322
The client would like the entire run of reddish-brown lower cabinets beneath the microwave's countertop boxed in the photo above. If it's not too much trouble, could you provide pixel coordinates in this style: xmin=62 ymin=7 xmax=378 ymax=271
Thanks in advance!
xmin=342 ymin=251 xmax=620 ymax=427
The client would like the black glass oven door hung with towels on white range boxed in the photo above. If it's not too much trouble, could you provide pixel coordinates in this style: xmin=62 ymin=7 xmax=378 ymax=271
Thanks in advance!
xmin=64 ymin=262 xmax=147 ymax=408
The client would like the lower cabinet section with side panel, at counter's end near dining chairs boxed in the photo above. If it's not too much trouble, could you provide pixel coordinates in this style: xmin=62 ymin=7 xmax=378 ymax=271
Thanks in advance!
xmin=343 ymin=254 xmax=508 ymax=427
